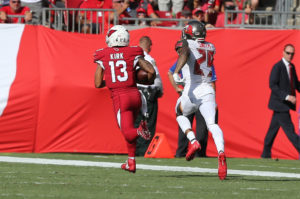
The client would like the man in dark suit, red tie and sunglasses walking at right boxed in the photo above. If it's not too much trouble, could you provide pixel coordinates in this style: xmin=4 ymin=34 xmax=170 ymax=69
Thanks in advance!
xmin=261 ymin=44 xmax=300 ymax=158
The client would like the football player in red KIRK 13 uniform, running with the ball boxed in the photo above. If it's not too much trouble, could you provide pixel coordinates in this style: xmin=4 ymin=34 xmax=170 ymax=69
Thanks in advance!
xmin=94 ymin=25 xmax=155 ymax=173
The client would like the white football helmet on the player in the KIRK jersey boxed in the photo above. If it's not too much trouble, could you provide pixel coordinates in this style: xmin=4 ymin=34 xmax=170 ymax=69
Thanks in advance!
xmin=106 ymin=25 xmax=129 ymax=47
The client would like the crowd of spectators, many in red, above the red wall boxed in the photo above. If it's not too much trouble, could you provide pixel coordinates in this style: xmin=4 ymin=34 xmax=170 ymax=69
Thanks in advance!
xmin=0 ymin=0 xmax=274 ymax=28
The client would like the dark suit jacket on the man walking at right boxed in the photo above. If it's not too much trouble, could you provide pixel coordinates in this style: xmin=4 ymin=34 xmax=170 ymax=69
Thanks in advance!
xmin=269 ymin=60 xmax=300 ymax=112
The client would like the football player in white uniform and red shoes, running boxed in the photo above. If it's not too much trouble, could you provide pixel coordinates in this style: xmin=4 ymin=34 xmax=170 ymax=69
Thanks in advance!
xmin=173 ymin=21 xmax=227 ymax=180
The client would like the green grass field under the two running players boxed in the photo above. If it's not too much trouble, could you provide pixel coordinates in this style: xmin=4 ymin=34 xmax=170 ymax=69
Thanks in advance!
xmin=0 ymin=153 xmax=300 ymax=199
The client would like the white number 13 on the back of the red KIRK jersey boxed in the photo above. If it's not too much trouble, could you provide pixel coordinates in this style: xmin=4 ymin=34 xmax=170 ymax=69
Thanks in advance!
xmin=108 ymin=60 xmax=128 ymax=83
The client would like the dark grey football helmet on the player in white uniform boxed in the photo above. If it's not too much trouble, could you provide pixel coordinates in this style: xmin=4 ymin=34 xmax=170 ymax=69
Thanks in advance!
xmin=181 ymin=21 xmax=206 ymax=41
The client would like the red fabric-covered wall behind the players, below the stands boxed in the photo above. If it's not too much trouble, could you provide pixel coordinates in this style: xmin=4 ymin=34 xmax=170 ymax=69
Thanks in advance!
xmin=0 ymin=26 xmax=300 ymax=159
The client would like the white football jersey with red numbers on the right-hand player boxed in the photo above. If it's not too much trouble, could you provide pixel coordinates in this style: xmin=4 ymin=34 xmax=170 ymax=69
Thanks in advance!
xmin=182 ymin=40 xmax=216 ymax=84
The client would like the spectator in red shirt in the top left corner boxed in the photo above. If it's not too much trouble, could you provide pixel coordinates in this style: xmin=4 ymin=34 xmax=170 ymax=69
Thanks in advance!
xmin=0 ymin=0 xmax=32 ymax=23
